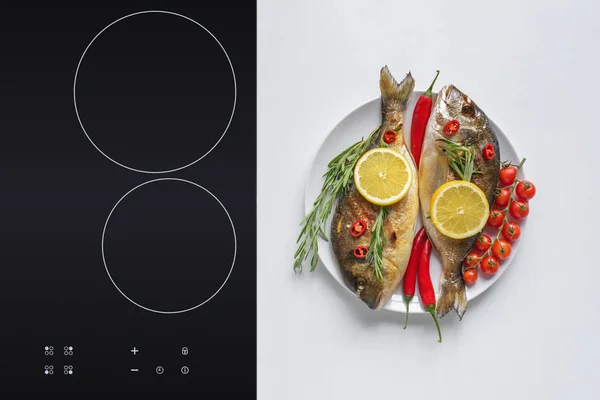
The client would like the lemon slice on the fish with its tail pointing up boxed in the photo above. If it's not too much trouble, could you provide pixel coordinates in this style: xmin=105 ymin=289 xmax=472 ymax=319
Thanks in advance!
xmin=354 ymin=148 xmax=413 ymax=206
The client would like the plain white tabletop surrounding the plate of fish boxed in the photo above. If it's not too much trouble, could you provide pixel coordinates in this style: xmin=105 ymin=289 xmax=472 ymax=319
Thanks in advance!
xmin=257 ymin=0 xmax=600 ymax=400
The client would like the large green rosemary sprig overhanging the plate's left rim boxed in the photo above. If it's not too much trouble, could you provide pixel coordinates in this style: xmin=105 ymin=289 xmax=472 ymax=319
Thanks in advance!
xmin=294 ymin=125 xmax=381 ymax=272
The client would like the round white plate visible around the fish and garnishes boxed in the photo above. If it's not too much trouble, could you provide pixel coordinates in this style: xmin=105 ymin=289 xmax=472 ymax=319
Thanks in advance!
xmin=304 ymin=91 xmax=526 ymax=313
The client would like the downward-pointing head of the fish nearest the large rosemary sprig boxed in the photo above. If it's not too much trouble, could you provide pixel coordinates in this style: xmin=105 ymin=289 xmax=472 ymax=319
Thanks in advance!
xmin=349 ymin=263 xmax=391 ymax=310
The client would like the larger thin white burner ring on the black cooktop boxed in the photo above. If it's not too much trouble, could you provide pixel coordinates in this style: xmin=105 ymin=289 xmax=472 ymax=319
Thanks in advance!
xmin=73 ymin=10 xmax=237 ymax=174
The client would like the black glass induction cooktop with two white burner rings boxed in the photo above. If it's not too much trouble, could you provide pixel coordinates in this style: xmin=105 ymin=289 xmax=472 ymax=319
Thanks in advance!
xmin=0 ymin=2 xmax=256 ymax=398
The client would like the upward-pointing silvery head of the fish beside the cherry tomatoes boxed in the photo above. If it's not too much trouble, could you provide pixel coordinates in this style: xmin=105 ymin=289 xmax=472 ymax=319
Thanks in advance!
xmin=431 ymin=85 xmax=487 ymax=142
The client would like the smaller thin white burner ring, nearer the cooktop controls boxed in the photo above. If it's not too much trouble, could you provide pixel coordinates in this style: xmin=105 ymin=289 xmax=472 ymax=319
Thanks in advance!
xmin=101 ymin=178 xmax=237 ymax=314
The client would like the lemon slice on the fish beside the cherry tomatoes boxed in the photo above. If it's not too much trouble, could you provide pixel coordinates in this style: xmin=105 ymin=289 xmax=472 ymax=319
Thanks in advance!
xmin=429 ymin=180 xmax=490 ymax=239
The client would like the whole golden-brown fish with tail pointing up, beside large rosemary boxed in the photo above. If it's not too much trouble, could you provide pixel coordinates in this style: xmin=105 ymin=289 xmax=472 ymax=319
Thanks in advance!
xmin=330 ymin=66 xmax=419 ymax=310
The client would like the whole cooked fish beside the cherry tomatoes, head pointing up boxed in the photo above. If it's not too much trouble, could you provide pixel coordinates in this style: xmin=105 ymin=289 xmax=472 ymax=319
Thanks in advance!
xmin=419 ymin=85 xmax=500 ymax=319
